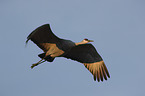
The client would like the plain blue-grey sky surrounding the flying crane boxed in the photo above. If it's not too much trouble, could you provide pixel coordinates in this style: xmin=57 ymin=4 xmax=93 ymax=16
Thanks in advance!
xmin=0 ymin=0 xmax=145 ymax=96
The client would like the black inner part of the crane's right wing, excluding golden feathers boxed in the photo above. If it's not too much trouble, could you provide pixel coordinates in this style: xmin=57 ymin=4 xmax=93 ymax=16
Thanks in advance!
xmin=64 ymin=44 xmax=102 ymax=63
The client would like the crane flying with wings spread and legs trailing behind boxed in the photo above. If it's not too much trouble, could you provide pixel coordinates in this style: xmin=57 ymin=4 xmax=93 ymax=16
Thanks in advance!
xmin=26 ymin=24 xmax=110 ymax=82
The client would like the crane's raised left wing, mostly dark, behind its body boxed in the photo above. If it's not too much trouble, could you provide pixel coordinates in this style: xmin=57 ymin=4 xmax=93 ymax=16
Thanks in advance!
xmin=26 ymin=24 xmax=60 ymax=52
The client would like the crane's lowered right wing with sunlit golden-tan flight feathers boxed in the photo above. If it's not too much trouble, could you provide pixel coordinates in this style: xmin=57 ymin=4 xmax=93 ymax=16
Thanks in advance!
xmin=64 ymin=44 xmax=110 ymax=81
